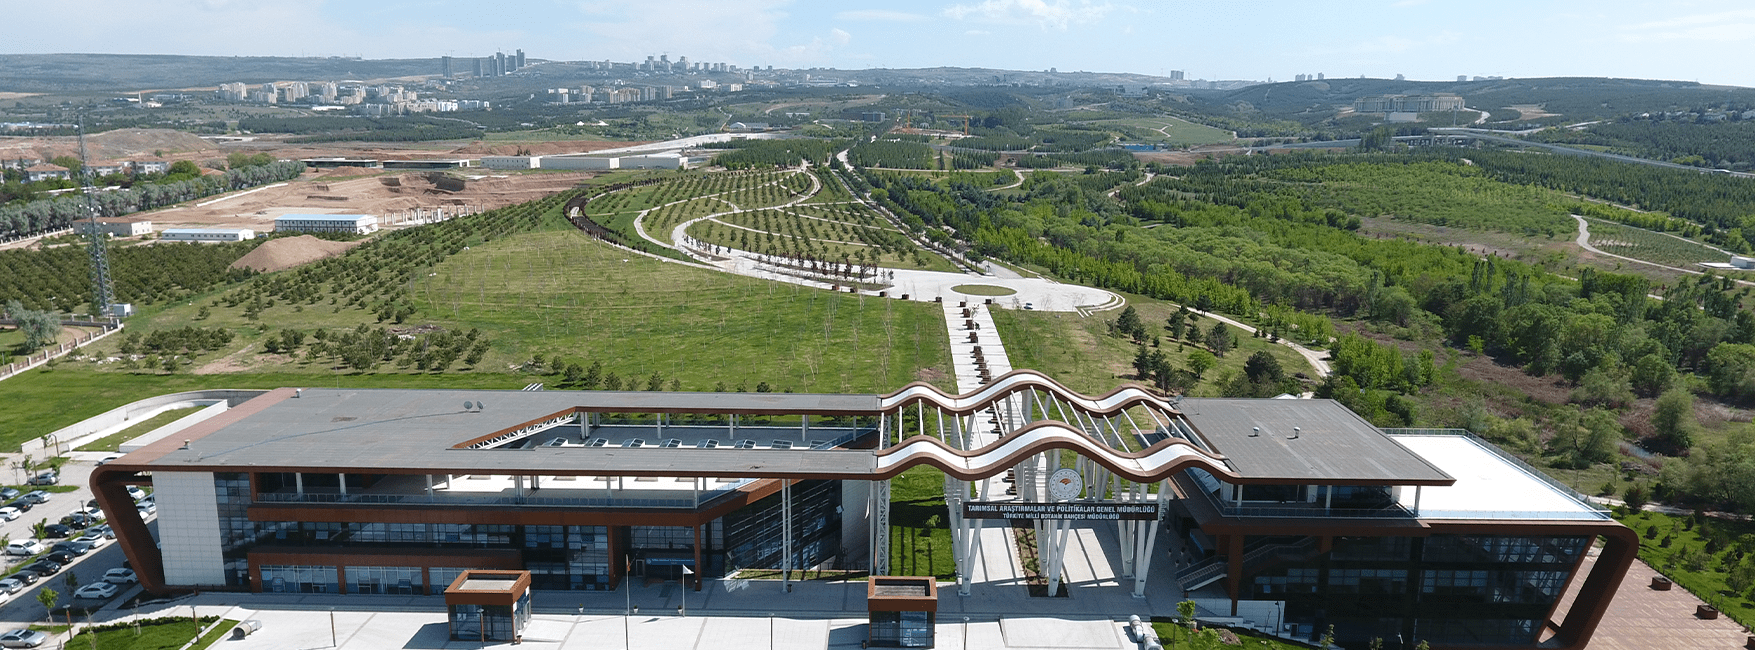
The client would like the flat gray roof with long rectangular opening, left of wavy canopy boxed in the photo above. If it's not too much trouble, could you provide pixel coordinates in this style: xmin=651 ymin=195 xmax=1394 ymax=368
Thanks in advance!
xmin=140 ymin=388 xmax=879 ymax=478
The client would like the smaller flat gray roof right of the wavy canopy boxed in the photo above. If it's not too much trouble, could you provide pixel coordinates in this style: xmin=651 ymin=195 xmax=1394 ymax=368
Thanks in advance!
xmin=1179 ymin=399 xmax=1455 ymax=485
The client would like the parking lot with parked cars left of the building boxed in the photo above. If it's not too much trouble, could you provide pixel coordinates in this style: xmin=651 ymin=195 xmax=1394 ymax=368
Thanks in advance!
xmin=0 ymin=451 xmax=156 ymax=629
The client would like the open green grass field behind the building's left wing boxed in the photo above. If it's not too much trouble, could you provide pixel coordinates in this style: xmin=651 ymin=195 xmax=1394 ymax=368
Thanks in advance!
xmin=414 ymin=230 xmax=949 ymax=392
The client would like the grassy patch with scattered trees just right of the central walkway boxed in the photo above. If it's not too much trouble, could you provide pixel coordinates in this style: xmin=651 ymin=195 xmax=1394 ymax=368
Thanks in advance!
xmin=993 ymin=295 xmax=1316 ymax=397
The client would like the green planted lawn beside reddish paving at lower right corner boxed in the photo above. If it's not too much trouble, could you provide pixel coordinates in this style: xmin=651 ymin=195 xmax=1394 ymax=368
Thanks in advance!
xmin=1616 ymin=513 xmax=1755 ymax=625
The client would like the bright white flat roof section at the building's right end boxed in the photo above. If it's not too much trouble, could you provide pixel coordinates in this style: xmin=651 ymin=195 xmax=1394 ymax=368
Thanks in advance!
xmin=1390 ymin=434 xmax=1609 ymax=520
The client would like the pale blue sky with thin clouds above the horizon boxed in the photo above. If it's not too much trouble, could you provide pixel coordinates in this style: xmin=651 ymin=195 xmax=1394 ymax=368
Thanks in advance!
xmin=0 ymin=0 xmax=1755 ymax=86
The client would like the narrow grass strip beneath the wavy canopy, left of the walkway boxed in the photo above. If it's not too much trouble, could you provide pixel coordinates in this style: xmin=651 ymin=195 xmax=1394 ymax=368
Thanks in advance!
xmin=890 ymin=467 xmax=956 ymax=580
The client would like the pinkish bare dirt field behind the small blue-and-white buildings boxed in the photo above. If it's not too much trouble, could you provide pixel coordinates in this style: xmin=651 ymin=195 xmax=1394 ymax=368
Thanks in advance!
xmin=135 ymin=169 xmax=597 ymax=232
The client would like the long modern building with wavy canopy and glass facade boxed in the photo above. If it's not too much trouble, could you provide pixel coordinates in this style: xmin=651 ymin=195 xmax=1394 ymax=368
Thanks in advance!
xmin=91 ymin=371 xmax=1639 ymax=648
